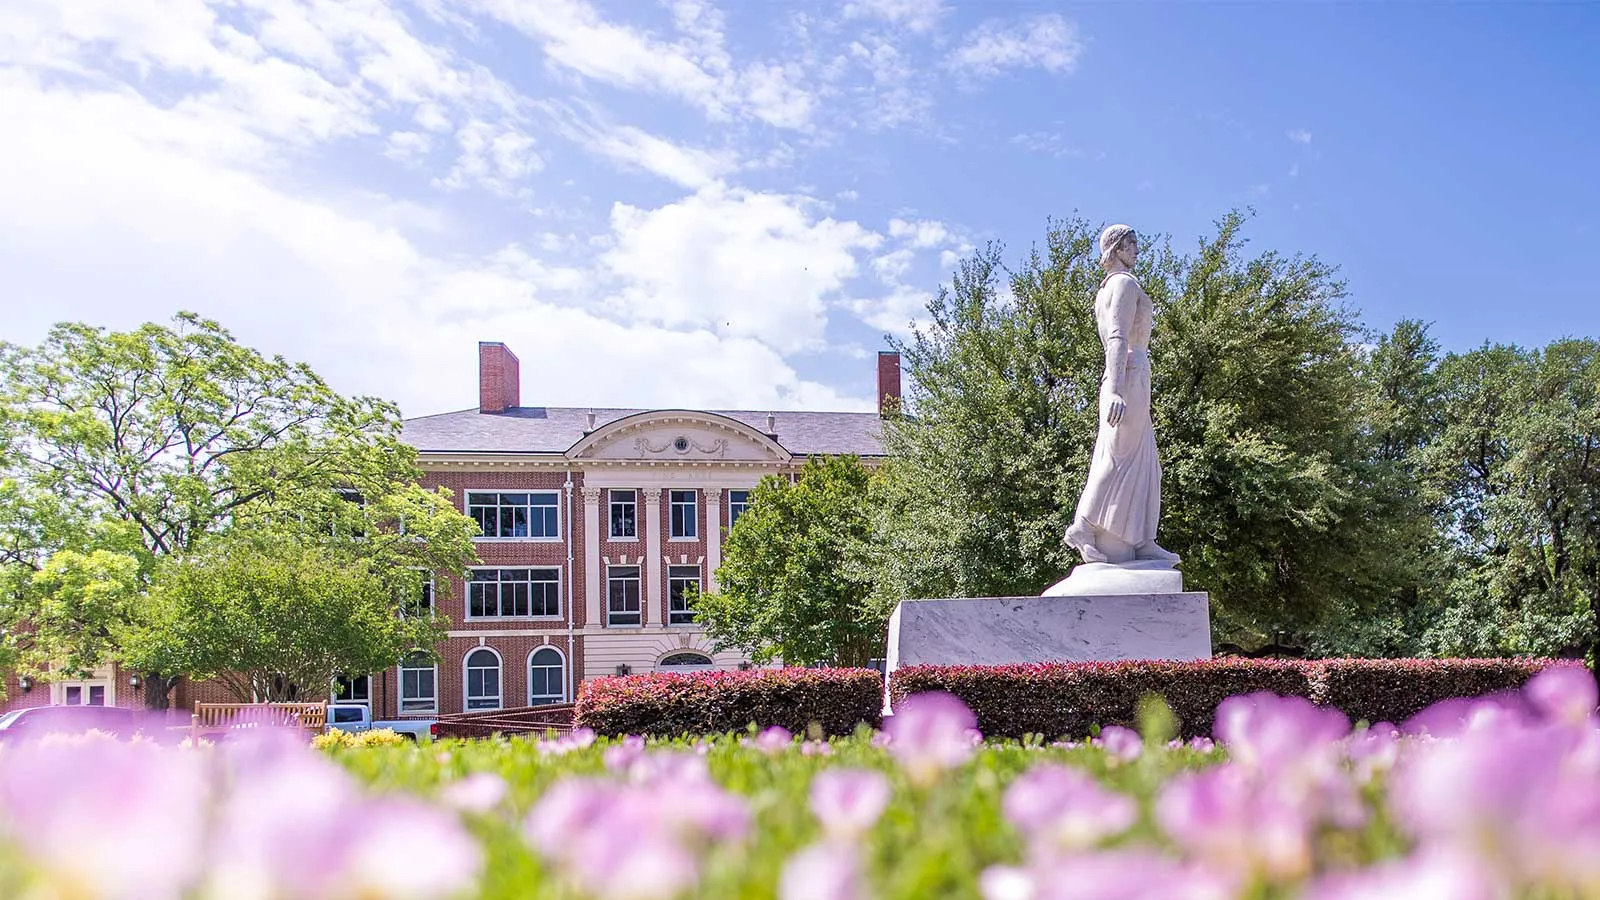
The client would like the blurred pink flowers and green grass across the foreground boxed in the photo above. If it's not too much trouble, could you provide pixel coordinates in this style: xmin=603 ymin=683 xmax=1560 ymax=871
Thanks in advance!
xmin=0 ymin=666 xmax=1600 ymax=900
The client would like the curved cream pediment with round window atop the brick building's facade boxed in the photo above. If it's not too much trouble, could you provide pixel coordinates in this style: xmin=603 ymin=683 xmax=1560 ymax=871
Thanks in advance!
xmin=566 ymin=410 xmax=790 ymax=463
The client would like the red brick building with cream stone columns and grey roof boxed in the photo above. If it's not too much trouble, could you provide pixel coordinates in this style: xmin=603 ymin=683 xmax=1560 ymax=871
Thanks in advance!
xmin=3 ymin=343 xmax=901 ymax=719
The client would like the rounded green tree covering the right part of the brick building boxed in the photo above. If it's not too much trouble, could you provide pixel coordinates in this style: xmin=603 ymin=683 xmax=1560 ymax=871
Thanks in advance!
xmin=696 ymin=456 xmax=888 ymax=666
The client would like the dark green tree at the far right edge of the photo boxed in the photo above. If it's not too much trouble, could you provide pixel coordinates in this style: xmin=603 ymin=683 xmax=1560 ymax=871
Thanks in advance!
xmin=1419 ymin=340 xmax=1600 ymax=655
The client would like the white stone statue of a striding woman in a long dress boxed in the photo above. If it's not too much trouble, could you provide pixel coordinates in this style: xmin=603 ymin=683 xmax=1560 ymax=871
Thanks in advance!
xmin=1066 ymin=224 xmax=1178 ymax=564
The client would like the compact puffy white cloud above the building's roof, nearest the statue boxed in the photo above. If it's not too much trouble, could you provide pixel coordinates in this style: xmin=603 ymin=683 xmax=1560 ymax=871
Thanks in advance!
xmin=603 ymin=186 xmax=882 ymax=352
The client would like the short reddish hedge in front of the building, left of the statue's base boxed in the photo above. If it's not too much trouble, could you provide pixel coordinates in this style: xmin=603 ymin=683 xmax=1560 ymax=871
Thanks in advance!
xmin=576 ymin=668 xmax=883 ymax=737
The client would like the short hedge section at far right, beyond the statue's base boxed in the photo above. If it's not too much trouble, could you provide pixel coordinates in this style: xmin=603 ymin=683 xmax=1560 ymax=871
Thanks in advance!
xmin=1307 ymin=658 xmax=1563 ymax=725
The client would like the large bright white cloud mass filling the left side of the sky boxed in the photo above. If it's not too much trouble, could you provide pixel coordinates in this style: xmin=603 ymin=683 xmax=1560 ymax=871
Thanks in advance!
xmin=0 ymin=0 xmax=882 ymax=415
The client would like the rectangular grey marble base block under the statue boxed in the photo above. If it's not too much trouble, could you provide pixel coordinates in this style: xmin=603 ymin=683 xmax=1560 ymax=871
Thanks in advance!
xmin=885 ymin=591 xmax=1211 ymax=673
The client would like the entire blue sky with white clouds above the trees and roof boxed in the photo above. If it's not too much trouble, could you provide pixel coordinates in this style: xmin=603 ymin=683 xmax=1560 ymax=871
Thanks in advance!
xmin=0 ymin=0 xmax=1600 ymax=415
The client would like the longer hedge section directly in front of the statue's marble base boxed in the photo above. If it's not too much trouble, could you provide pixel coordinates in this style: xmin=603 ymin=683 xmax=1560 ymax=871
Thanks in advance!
xmin=890 ymin=660 xmax=1310 ymax=738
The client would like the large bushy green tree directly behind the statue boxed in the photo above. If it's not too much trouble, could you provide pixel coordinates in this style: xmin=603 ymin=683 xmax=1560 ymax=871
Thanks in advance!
xmin=874 ymin=213 xmax=1403 ymax=644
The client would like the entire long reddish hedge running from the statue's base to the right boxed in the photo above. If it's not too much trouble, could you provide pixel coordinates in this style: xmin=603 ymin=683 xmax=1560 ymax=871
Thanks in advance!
xmin=890 ymin=658 xmax=1573 ymax=738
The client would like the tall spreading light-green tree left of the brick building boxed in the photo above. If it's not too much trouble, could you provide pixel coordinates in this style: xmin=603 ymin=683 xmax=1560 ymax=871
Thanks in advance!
xmin=0 ymin=312 xmax=472 ymax=708
